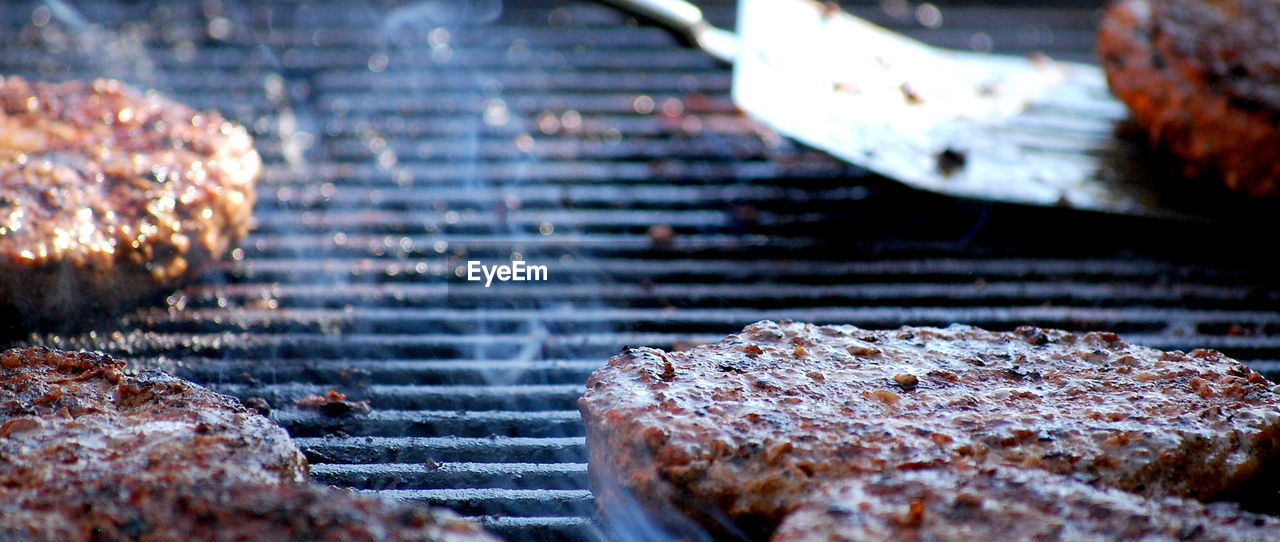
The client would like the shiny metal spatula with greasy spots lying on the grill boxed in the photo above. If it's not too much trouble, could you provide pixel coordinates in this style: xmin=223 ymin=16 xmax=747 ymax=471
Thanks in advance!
xmin=607 ymin=0 xmax=1249 ymax=218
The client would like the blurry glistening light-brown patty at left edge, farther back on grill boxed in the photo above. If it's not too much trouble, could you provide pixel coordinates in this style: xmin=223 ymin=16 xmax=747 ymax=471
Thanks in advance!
xmin=0 ymin=77 xmax=261 ymax=325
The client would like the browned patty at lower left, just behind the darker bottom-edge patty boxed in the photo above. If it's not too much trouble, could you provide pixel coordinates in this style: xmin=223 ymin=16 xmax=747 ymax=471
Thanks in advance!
xmin=0 ymin=347 xmax=307 ymax=492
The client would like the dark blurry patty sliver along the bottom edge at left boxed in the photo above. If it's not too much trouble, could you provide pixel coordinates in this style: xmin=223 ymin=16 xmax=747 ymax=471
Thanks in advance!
xmin=0 ymin=480 xmax=497 ymax=542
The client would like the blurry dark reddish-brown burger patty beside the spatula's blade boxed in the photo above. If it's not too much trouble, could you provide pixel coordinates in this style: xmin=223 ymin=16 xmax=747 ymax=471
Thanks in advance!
xmin=1098 ymin=0 xmax=1280 ymax=196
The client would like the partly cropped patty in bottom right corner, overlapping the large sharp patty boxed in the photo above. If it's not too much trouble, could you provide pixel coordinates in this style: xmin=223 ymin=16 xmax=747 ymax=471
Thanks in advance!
xmin=773 ymin=469 xmax=1280 ymax=542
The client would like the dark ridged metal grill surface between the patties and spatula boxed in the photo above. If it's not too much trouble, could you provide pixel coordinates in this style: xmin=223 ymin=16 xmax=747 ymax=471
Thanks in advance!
xmin=0 ymin=0 xmax=1280 ymax=539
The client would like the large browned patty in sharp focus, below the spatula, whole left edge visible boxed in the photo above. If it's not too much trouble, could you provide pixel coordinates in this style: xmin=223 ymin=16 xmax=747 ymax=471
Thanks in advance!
xmin=579 ymin=322 xmax=1280 ymax=537
